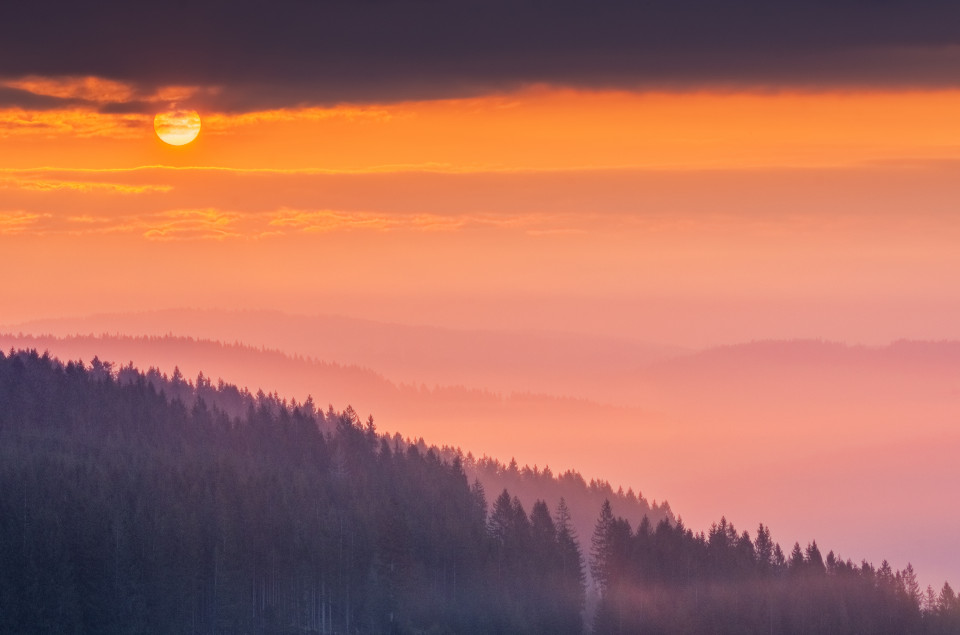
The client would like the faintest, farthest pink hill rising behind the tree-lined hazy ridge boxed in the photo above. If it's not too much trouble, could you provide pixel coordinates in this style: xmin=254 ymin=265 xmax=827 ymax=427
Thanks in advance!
xmin=0 ymin=309 xmax=681 ymax=403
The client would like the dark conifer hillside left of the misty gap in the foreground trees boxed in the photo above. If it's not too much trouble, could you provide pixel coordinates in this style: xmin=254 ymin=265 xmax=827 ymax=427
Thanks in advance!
xmin=0 ymin=353 xmax=583 ymax=633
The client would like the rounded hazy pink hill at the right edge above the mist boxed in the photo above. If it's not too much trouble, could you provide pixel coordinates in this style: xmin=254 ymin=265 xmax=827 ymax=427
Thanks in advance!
xmin=628 ymin=340 xmax=960 ymax=426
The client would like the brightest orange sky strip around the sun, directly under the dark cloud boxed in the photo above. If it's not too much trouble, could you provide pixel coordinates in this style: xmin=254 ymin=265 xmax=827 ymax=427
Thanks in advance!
xmin=0 ymin=88 xmax=960 ymax=171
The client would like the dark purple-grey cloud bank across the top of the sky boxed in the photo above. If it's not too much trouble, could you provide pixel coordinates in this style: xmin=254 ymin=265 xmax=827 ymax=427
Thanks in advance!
xmin=0 ymin=0 xmax=960 ymax=111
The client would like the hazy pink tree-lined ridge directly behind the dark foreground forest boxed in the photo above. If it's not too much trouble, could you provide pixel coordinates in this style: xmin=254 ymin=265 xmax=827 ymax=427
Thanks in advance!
xmin=0 ymin=328 xmax=663 ymax=492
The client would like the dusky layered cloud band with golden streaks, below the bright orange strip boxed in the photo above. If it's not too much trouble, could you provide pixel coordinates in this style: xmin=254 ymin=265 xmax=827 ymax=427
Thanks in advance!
xmin=0 ymin=161 xmax=960 ymax=253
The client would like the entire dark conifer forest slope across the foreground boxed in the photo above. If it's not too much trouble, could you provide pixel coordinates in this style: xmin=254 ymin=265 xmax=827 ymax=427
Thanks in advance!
xmin=0 ymin=352 xmax=960 ymax=633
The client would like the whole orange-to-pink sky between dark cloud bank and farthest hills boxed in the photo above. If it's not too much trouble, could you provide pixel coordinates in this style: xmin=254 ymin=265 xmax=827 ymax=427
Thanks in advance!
xmin=0 ymin=77 xmax=960 ymax=588
